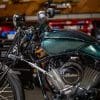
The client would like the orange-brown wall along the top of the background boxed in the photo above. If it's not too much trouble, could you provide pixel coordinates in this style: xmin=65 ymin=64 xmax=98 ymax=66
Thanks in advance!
xmin=0 ymin=0 xmax=100 ymax=16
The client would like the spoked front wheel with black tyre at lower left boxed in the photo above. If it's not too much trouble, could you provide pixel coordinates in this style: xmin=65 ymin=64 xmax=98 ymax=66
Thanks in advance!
xmin=0 ymin=66 xmax=24 ymax=100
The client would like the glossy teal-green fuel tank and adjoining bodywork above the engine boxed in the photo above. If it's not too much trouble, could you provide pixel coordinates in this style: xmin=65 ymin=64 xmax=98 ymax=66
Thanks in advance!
xmin=41 ymin=30 xmax=100 ymax=59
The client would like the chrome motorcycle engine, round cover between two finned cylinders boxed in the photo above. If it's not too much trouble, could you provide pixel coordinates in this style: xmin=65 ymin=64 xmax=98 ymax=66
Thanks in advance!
xmin=47 ymin=62 xmax=100 ymax=95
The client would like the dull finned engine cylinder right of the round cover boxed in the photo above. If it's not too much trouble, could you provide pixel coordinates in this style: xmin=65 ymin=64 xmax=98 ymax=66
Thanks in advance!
xmin=80 ymin=67 xmax=100 ymax=90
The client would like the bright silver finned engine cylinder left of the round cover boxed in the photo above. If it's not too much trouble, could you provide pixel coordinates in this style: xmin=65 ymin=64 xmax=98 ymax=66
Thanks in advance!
xmin=47 ymin=69 xmax=73 ymax=94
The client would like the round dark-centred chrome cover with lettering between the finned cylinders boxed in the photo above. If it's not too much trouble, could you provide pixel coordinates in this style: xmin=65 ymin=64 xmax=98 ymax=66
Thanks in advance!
xmin=59 ymin=62 xmax=83 ymax=85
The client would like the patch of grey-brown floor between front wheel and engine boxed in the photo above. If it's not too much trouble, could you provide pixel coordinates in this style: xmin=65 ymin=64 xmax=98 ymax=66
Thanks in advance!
xmin=25 ymin=88 xmax=44 ymax=100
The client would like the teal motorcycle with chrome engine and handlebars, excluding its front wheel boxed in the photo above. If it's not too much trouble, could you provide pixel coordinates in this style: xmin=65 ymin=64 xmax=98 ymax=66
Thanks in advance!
xmin=8 ymin=11 xmax=100 ymax=100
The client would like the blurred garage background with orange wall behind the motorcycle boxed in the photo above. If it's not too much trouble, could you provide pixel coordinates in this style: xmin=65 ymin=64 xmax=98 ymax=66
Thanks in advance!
xmin=0 ymin=0 xmax=100 ymax=100
